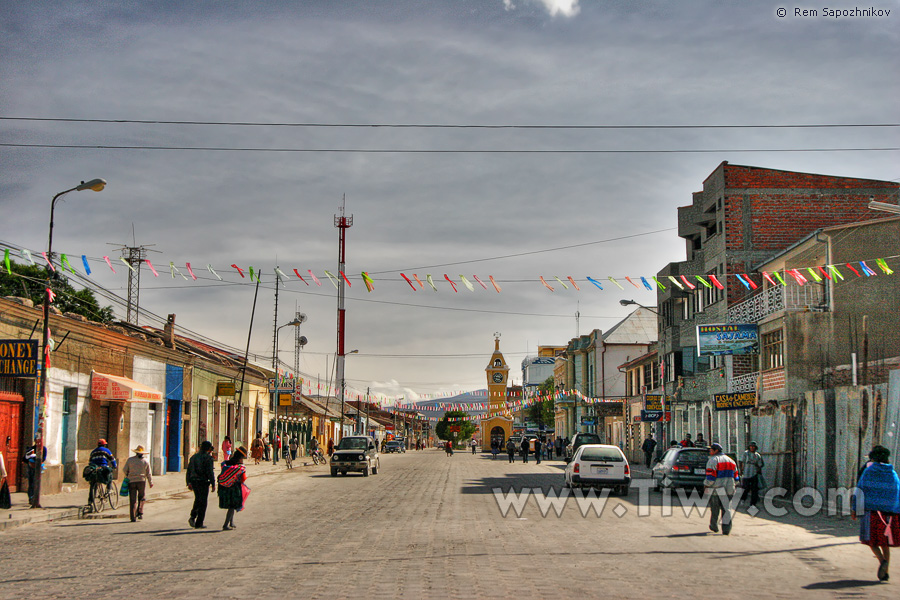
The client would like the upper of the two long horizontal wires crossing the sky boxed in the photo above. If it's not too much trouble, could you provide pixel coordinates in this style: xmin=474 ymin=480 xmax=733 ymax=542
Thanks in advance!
xmin=0 ymin=117 xmax=900 ymax=130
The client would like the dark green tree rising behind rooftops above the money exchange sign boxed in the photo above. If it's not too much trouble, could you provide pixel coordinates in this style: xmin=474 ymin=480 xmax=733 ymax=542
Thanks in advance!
xmin=0 ymin=261 xmax=115 ymax=323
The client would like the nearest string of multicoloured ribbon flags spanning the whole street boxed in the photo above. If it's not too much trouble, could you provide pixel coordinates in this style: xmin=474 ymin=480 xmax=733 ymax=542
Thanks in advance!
xmin=3 ymin=248 xmax=900 ymax=294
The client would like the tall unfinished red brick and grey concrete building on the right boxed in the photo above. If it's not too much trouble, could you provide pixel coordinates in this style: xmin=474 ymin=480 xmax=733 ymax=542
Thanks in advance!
xmin=657 ymin=162 xmax=900 ymax=450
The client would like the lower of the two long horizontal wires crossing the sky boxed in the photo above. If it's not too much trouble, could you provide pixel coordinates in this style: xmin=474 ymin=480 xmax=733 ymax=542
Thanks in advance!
xmin=0 ymin=143 xmax=900 ymax=154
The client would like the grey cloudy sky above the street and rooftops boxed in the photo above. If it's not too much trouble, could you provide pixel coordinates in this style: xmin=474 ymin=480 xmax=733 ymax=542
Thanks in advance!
xmin=0 ymin=0 xmax=900 ymax=401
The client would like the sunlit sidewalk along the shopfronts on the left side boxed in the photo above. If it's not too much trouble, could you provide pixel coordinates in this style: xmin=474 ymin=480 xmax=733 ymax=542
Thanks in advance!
xmin=0 ymin=456 xmax=313 ymax=531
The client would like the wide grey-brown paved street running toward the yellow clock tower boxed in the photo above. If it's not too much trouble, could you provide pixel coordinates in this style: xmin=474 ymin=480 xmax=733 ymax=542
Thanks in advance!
xmin=0 ymin=450 xmax=900 ymax=599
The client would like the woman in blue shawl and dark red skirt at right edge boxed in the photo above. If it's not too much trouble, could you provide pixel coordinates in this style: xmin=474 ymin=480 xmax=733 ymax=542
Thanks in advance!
xmin=850 ymin=446 xmax=900 ymax=581
